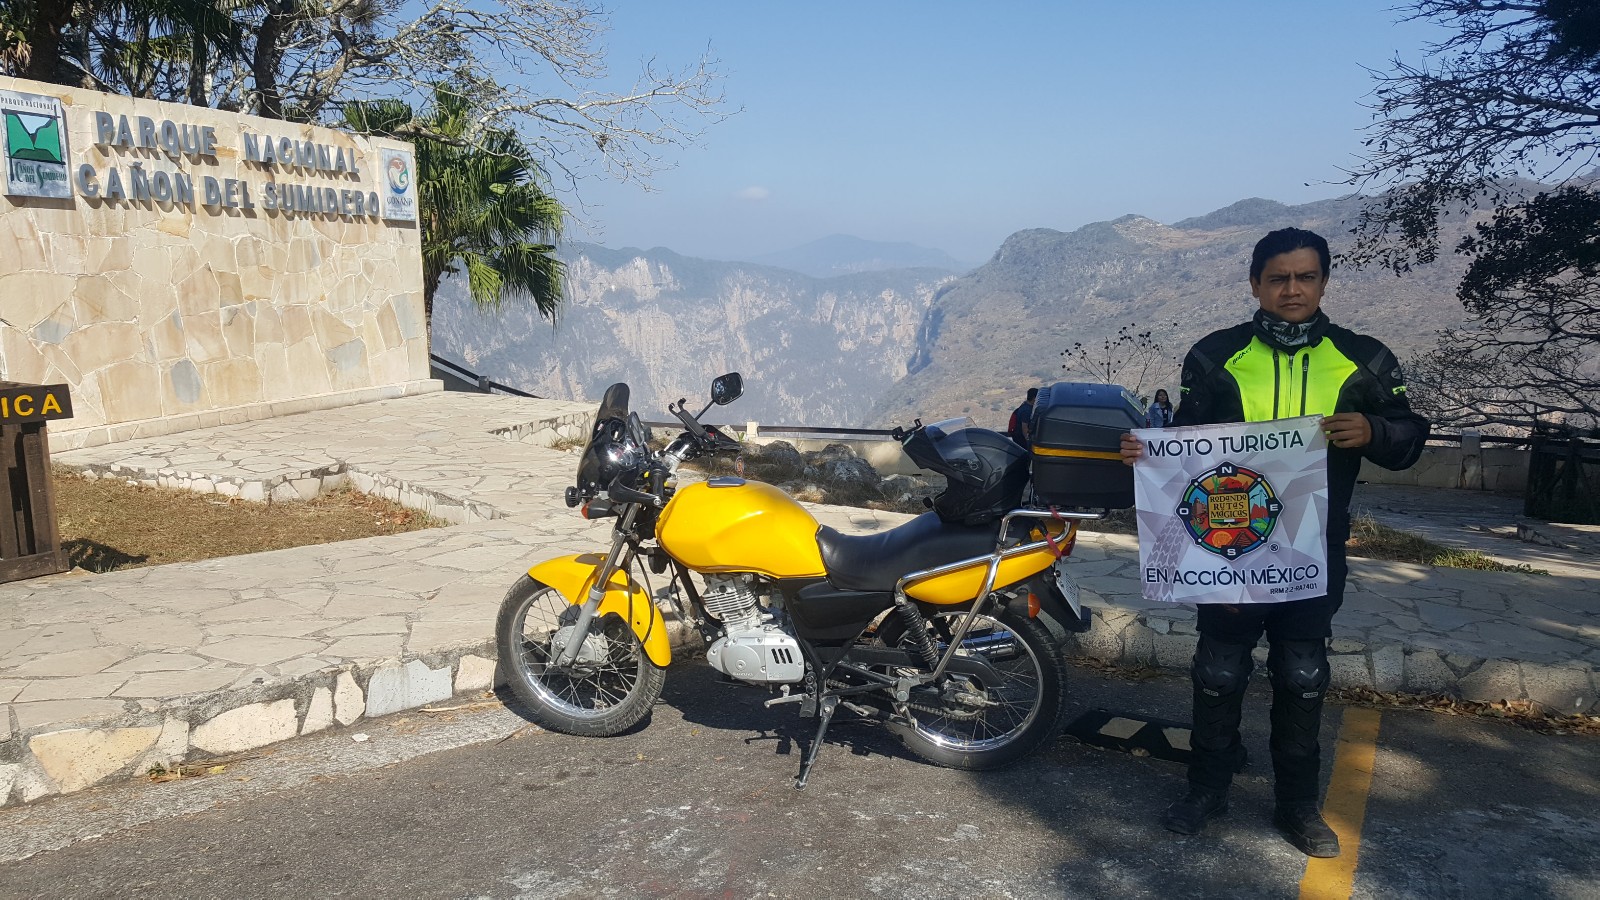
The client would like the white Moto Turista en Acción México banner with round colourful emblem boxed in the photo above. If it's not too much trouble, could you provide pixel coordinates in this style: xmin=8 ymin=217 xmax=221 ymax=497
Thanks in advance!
xmin=1133 ymin=416 xmax=1328 ymax=604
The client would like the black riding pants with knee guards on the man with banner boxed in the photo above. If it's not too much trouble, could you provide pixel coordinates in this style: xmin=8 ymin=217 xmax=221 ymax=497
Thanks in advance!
xmin=1189 ymin=548 xmax=1346 ymax=802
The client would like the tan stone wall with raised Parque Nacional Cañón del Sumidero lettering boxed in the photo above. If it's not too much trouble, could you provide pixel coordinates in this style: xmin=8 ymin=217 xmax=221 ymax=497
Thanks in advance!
xmin=0 ymin=77 xmax=438 ymax=448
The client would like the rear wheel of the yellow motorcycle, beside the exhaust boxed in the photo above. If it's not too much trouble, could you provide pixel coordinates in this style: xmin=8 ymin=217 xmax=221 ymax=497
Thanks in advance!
xmin=877 ymin=609 xmax=1067 ymax=770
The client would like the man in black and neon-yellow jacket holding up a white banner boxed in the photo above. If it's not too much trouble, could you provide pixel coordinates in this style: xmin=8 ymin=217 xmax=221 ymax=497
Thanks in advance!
xmin=1122 ymin=227 xmax=1427 ymax=857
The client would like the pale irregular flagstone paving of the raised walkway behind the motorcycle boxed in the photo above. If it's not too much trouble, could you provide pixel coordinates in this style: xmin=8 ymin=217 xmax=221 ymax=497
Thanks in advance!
xmin=0 ymin=392 xmax=1600 ymax=806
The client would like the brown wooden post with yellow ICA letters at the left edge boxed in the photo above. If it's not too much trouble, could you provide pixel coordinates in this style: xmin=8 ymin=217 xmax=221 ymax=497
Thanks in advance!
xmin=0 ymin=381 xmax=72 ymax=581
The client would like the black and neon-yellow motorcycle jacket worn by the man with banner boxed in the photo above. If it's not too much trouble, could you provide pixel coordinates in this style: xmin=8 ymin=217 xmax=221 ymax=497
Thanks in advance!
xmin=1173 ymin=322 xmax=1427 ymax=538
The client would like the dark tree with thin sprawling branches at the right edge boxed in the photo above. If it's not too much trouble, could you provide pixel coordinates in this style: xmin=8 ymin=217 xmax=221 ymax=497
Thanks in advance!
xmin=1341 ymin=0 xmax=1600 ymax=428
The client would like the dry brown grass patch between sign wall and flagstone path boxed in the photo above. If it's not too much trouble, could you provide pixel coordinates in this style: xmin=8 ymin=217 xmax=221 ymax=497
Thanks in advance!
xmin=51 ymin=468 xmax=445 ymax=572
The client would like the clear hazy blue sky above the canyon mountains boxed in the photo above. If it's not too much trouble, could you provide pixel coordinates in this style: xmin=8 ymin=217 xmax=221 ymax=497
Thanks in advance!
xmin=571 ymin=0 xmax=1437 ymax=263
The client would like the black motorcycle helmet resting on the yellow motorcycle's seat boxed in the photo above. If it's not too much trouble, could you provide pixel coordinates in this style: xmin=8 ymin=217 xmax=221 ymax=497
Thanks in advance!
xmin=904 ymin=418 xmax=1027 ymax=525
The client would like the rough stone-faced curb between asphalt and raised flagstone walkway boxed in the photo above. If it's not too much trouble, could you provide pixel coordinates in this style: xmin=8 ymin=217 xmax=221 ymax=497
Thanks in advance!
xmin=0 ymin=607 xmax=1600 ymax=807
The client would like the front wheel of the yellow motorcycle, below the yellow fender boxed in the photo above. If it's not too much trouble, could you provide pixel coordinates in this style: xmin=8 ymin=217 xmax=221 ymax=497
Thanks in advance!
xmin=494 ymin=575 xmax=667 ymax=737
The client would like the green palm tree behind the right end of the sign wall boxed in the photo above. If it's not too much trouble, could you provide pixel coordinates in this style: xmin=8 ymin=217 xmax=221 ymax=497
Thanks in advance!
xmin=344 ymin=86 xmax=566 ymax=337
